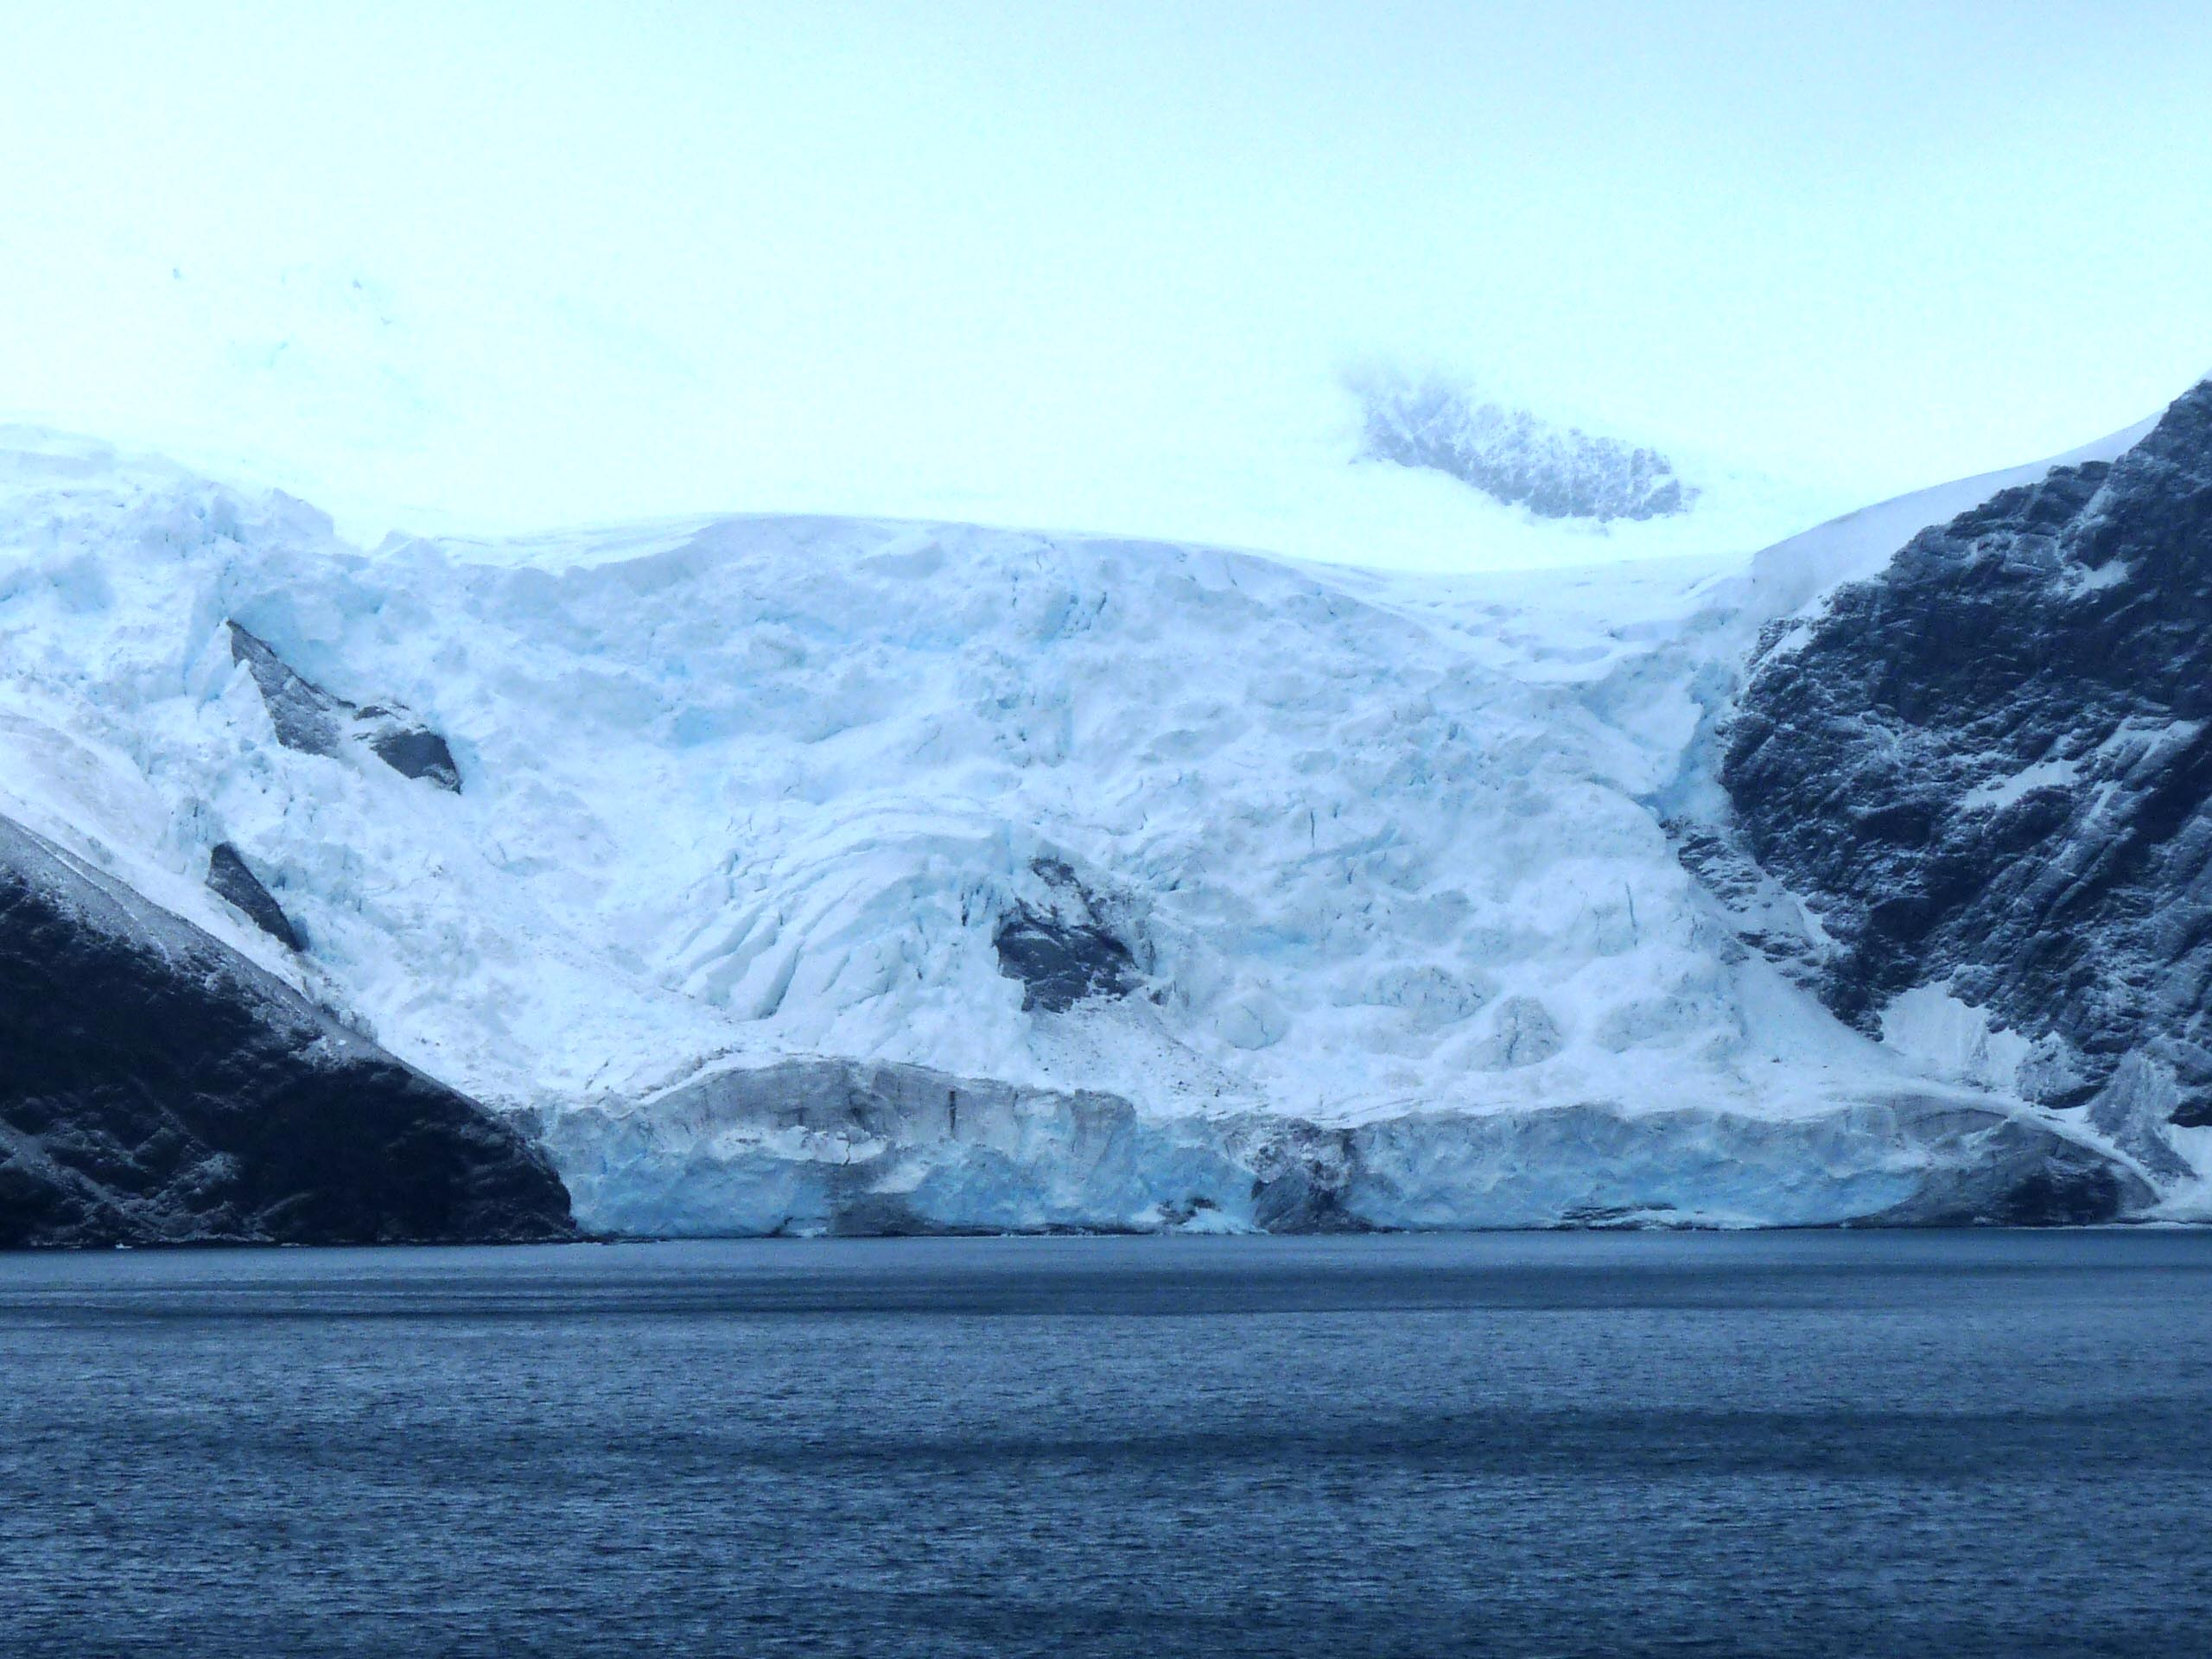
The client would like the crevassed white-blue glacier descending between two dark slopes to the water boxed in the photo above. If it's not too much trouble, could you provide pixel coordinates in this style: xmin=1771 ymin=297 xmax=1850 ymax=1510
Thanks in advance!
xmin=0 ymin=389 xmax=2199 ymax=1232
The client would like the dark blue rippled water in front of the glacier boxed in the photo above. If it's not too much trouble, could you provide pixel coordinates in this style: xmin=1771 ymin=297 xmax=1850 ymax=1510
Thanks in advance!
xmin=0 ymin=1232 xmax=2212 ymax=1659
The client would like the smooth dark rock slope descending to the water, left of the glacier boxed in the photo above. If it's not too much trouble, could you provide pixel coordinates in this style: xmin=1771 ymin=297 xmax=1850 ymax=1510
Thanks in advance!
xmin=0 ymin=818 xmax=575 ymax=1245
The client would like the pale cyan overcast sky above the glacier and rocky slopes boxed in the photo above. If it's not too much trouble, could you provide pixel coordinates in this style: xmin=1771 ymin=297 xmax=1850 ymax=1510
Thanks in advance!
xmin=0 ymin=0 xmax=2212 ymax=569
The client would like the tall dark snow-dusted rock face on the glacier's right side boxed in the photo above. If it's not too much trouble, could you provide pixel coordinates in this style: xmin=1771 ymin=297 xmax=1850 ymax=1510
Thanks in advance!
xmin=1721 ymin=383 xmax=2212 ymax=1173
